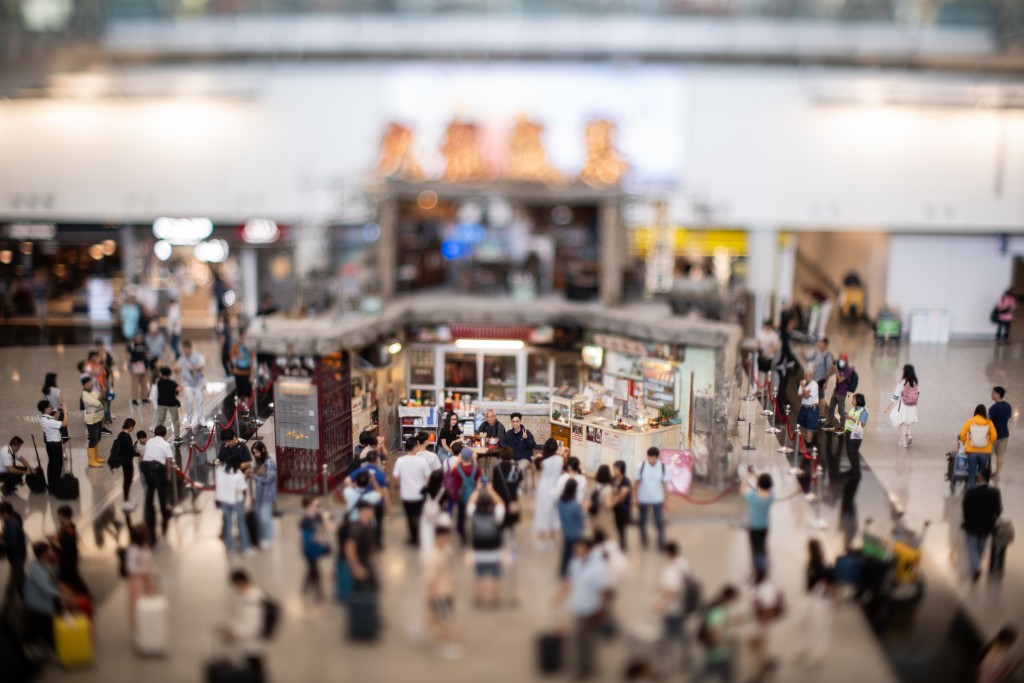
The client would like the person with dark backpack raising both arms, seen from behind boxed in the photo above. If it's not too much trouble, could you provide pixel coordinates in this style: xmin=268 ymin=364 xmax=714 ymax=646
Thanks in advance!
xmin=466 ymin=485 xmax=505 ymax=609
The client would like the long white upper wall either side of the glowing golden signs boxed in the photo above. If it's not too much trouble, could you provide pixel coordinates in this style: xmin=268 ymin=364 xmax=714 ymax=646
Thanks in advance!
xmin=0 ymin=62 xmax=1024 ymax=232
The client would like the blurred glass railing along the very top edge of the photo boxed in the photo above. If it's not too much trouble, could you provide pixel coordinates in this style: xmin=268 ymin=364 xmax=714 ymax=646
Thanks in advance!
xmin=105 ymin=0 xmax=999 ymax=26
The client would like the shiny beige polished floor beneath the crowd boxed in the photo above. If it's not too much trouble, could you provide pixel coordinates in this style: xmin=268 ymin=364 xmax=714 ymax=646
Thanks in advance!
xmin=0 ymin=333 xmax=1024 ymax=682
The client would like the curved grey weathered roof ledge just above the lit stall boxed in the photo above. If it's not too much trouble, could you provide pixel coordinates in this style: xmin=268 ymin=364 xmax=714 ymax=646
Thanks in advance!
xmin=249 ymin=293 xmax=740 ymax=355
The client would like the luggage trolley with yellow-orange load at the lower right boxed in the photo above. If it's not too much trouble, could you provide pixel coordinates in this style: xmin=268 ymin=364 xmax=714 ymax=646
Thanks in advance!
xmin=862 ymin=516 xmax=930 ymax=602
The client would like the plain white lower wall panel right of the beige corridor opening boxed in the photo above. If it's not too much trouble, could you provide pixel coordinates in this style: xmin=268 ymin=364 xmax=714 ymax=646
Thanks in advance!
xmin=887 ymin=234 xmax=1024 ymax=337
